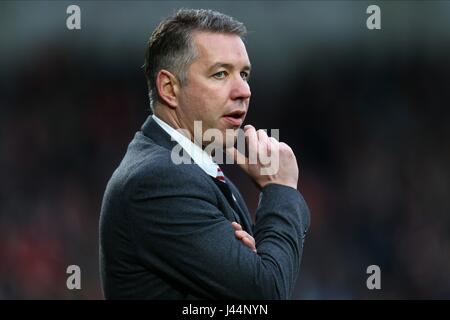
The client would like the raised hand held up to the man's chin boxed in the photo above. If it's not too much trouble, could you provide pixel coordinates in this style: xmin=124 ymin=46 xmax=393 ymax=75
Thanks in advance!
xmin=226 ymin=125 xmax=298 ymax=189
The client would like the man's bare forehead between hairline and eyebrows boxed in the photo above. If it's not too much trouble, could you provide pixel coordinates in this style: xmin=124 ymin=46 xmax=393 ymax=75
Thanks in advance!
xmin=192 ymin=32 xmax=250 ymax=67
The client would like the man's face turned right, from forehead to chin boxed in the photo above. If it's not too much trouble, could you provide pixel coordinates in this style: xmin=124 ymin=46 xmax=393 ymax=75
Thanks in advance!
xmin=178 ymin=32 xmax=251 ymax=144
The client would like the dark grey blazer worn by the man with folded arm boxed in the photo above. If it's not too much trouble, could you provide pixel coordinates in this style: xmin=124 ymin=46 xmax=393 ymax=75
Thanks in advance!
xmin=100 ymin=117 xmax=310 ymax=299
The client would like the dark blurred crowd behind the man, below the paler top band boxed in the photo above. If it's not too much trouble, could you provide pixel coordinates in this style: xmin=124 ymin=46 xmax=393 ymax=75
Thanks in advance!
xmin=0 ymin=39 xmax=450 ymax=299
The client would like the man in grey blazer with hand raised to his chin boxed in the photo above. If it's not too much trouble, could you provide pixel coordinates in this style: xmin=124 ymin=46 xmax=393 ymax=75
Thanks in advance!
xmin=100 ymin=9 xmax=309 ymax=299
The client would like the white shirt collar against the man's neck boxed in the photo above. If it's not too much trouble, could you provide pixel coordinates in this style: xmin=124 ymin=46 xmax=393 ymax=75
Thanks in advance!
xmin=152 ymin=115 xmax=219 ymax=178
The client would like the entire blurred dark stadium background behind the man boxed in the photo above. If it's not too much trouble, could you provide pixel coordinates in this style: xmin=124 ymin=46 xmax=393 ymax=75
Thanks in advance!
xmin=0 ymin=1 xmax=450 ymax=299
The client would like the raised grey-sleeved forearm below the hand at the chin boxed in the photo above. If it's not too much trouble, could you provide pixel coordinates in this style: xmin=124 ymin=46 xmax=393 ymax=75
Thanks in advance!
xmin=254 ymin=184 xmax=309 ymax=299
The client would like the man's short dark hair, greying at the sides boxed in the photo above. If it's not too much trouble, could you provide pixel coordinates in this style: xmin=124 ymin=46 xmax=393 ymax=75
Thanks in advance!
xmin=143 ymin=9 xmax=247 ymax=111
